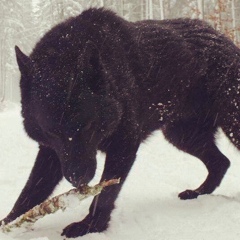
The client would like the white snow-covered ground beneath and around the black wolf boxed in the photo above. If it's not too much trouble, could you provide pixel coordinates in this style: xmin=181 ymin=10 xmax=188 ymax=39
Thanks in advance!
xmin=0 ymin=104 xmax=240 ymax=240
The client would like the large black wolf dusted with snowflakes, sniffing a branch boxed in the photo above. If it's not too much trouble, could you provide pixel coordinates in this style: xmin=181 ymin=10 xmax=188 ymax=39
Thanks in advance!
xmin=0 ymin=9 xmax=240 ymax=237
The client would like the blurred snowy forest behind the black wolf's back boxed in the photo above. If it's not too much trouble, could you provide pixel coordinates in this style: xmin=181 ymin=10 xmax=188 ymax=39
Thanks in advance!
xmin=0 ymin=0 xmax=240 ymax=102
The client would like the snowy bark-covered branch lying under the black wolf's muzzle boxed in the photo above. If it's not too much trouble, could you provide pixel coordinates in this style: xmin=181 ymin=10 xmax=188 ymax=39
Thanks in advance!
xmin=0 ymin=179 xmax=120 ymax=232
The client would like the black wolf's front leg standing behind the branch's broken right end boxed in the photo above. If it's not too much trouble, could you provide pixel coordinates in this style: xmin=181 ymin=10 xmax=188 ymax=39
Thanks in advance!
xmin=62 ymin=136 xmax=139 ymax=237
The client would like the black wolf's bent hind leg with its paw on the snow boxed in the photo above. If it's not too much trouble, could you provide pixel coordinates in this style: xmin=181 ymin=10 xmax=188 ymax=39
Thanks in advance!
xmin=163 ymin=121 xmax=230 ymax=199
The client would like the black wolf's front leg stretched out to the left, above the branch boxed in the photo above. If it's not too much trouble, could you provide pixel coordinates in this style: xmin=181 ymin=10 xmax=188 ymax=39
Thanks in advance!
xmin=0 ymin=146 xmax=62 ymax=225
